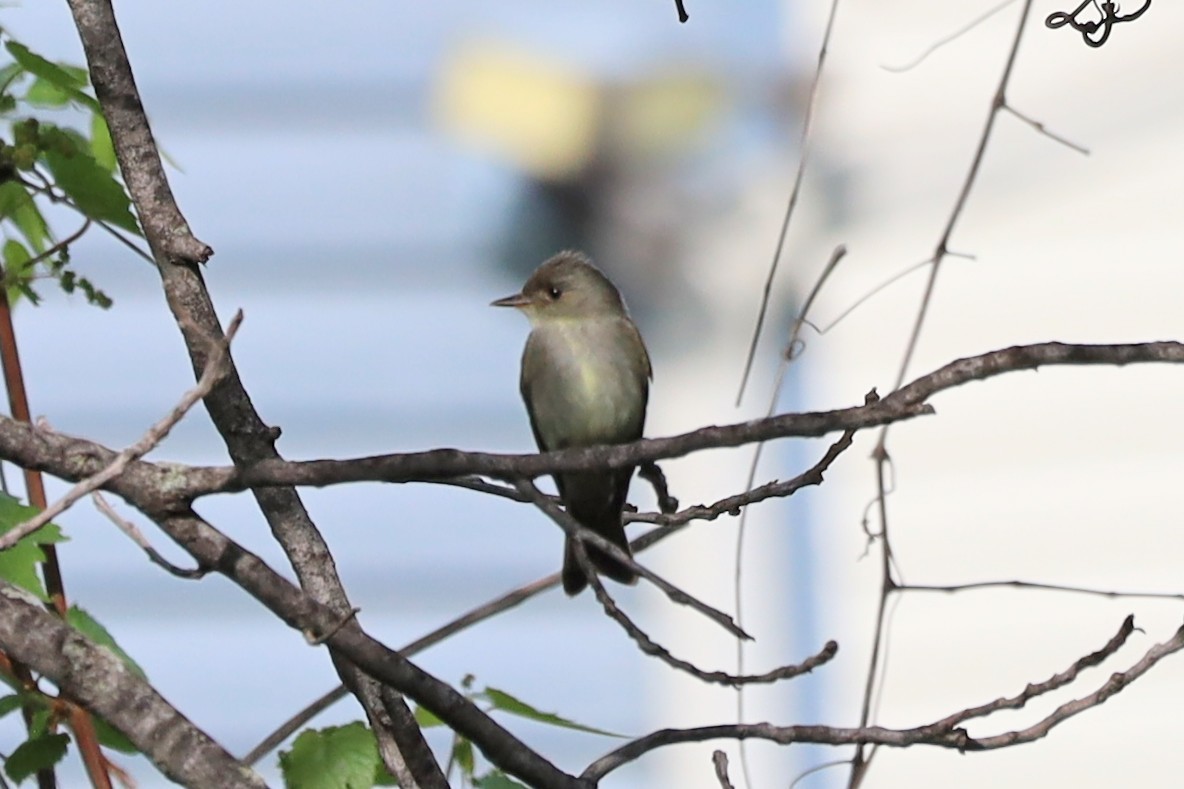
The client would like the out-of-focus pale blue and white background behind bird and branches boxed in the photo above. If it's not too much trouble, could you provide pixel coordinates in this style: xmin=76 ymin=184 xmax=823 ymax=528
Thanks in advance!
xmin=0 ymin=0 xmax=1184 ymax=787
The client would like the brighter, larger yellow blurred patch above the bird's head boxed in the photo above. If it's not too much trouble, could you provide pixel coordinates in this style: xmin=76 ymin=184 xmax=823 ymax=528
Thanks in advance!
xmin=436 ymin=41 xmax=603 ymax=180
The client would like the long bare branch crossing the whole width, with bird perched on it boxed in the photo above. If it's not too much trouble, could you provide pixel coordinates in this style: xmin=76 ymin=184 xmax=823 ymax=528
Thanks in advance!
xmin=0 ymin=341 xmax=1184 ymax=514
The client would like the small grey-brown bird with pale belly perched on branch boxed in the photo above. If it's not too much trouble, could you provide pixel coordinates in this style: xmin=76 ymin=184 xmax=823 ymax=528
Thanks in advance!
xmin=493 ymin=251 xmax=652 ymax=595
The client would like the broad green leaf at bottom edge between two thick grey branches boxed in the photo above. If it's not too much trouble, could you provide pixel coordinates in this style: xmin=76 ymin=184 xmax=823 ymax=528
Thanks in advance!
xmin=279 ymin=723 xmax=380 ymax=789
